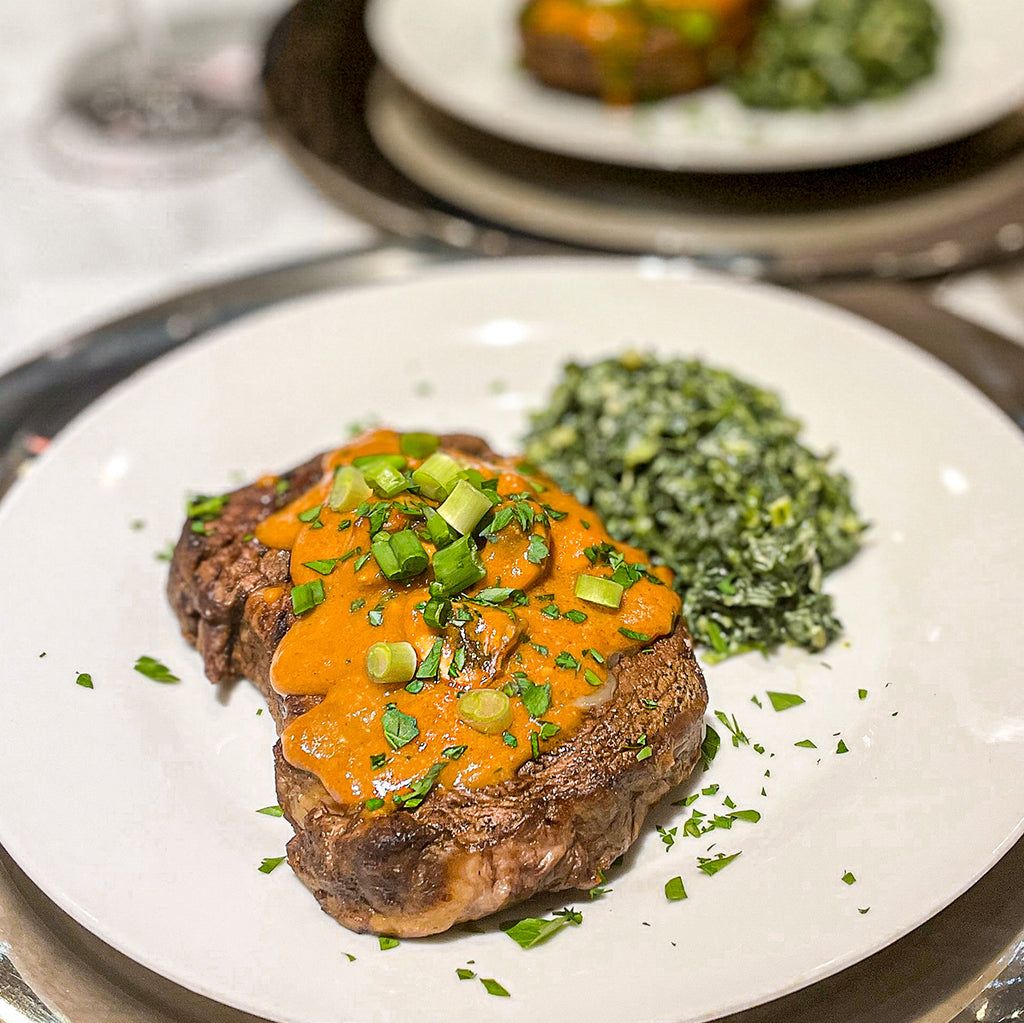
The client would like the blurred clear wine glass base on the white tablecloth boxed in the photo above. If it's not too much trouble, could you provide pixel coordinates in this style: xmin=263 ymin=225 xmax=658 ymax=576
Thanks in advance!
xmin=40 ymin=0 xmax=272 ymax=184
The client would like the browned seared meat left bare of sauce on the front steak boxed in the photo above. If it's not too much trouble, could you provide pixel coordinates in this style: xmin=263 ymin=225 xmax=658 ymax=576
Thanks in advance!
xmin=167 ymin=435 xmax=707 ymax=937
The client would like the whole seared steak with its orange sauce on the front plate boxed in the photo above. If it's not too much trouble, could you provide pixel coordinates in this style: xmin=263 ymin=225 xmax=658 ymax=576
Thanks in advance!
xmin=168 ymin=431 xmax=707 ymax=935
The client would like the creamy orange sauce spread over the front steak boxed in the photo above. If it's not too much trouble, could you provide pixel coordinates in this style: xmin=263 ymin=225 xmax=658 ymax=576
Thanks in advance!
xmin=256 ymin=430 xmax=680 ymax=812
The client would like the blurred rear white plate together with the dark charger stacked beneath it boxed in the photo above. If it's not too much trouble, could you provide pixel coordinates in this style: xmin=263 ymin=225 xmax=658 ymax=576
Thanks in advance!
xmin=258 ymin=0 xmax=1024 ymax=280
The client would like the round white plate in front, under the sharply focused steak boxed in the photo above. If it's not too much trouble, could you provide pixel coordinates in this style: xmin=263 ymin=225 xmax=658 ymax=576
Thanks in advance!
xmin=0 ymin=260 xmax=1024 ymax=1023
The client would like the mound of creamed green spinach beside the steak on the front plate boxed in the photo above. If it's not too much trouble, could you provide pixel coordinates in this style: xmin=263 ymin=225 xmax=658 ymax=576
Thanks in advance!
xmin=525 ymin=352 xmax=866 ymax=659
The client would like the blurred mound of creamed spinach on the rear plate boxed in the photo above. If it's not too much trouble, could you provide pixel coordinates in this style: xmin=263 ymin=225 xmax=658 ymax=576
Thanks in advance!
xmin=726 ymin=0 xmax=942 ymax=110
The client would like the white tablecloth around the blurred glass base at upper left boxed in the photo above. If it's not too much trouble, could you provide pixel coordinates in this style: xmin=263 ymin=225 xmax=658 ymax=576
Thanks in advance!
xmin=0 ymin=0 xmax=372 ymax=371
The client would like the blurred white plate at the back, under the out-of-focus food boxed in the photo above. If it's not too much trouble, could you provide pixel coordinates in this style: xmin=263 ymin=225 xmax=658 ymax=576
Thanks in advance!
xmin=368 ymin=0 xmax=1024 ymax=171
